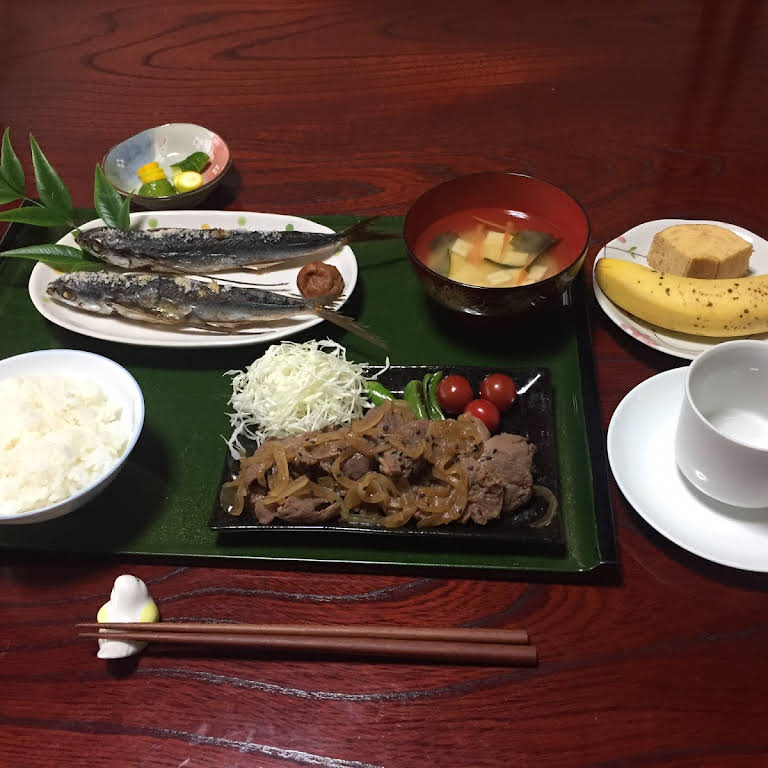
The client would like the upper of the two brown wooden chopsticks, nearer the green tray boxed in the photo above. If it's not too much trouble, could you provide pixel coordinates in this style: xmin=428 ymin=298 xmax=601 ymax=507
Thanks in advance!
xmin=81 ymin=621 xmax=528 ymax=645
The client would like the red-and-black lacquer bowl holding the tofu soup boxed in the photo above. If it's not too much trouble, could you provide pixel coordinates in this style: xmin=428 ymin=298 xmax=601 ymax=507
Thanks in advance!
xmin=404 ymin=171 xmax=589 ymax=317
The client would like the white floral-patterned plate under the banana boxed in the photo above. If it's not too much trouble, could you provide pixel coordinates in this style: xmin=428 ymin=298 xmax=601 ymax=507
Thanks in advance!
xmin=592 ymin=219 xmax=768 ymax=360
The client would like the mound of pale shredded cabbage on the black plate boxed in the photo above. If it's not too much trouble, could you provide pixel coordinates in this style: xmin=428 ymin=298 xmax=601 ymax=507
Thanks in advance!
xmin=225 ymin=339 xmax=371 ymax=459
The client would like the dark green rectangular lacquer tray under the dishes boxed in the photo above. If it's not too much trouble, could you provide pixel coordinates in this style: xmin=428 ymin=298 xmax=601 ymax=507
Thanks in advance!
xmin=0 ymin=216 xmax=617 ymax=577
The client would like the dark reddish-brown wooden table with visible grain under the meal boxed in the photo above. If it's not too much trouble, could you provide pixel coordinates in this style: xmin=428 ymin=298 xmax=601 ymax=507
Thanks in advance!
xmin=0 ymin=0 xmax=768 ymax=768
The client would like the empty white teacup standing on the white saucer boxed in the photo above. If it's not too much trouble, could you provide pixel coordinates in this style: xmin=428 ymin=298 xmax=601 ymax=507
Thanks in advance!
xmin=676 ymin=340 xmax=768 ymax=507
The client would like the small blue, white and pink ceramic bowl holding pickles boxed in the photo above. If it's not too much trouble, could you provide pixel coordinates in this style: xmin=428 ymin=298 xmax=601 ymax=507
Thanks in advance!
xmin=101 ymin=123 xmax=232 ymax=210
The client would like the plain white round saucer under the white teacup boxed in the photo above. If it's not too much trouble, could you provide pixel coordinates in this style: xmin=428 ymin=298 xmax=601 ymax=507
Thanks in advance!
xmin=608 ymin=368 xmax=768 ymax=573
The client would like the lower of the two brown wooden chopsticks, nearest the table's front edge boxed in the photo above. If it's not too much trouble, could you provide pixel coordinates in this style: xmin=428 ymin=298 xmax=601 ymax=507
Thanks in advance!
xmin=80 ymin=622 xmax=538 ymax=667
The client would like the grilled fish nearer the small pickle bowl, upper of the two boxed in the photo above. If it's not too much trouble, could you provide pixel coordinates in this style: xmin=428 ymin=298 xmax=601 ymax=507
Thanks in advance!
xmin=75 ymin=216 xmax=397 ymax=275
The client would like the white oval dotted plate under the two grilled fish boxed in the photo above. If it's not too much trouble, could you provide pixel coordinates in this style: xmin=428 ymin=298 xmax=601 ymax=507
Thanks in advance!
xmin=29 ymin=211 xmax=357 ymax=347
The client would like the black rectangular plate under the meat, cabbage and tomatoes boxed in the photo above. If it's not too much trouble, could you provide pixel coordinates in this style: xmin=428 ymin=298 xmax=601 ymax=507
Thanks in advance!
xmin=209 ymin=365 xmax=565 ymax=553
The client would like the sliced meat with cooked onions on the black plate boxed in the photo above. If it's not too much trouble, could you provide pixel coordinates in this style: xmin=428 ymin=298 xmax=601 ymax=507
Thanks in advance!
xmin=233 ymin=403 xmax=534 ymax=527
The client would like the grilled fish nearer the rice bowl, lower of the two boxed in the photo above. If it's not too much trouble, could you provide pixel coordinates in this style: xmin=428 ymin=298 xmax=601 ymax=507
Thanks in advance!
xmin=46 ymin=271 xmax=385 ymax=347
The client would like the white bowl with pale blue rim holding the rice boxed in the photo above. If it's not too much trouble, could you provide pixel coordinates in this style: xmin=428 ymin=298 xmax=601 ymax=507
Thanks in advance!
xmin=0 ymin=349 xmax=144 ymax=525
